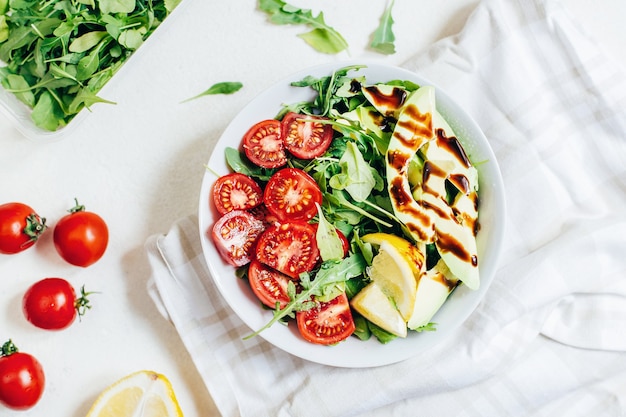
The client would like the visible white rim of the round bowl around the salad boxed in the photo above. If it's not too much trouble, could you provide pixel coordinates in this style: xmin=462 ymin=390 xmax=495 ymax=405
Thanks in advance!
xmin=199 ymin=63 xmax=505 ymax=368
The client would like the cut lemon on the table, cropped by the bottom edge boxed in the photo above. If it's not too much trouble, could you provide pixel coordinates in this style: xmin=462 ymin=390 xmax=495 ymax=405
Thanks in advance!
xmin=87 ymin=371 xmax=183 ymax=417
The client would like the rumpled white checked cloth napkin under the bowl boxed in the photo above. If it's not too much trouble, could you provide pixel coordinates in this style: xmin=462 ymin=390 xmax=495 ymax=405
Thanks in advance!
xmin=146 ymin=0 xmax=626 ymax=417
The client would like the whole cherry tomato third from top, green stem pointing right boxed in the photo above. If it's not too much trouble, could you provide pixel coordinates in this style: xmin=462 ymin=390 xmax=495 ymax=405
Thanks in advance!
xmin=22 ymin=278 xmax=91 ymax=330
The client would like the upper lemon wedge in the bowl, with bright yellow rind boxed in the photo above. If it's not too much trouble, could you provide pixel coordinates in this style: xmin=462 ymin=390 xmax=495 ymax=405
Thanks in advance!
xmin=363 ymin=234 xmax=423 ymax=320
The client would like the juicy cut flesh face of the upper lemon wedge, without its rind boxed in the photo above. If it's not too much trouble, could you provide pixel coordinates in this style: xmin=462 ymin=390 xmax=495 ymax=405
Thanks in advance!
xmin=368 ymin=236 xmax=419 ymax=322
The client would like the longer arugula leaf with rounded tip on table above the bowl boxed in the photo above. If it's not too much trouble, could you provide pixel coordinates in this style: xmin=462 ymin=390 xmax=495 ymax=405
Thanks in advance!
xmin=259 ymin=0 xmax=348 ymax=54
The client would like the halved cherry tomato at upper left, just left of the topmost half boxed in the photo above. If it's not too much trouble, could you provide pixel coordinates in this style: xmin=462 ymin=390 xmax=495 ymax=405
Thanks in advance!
xmin=243 ymin=119 xmax=287 ymax=168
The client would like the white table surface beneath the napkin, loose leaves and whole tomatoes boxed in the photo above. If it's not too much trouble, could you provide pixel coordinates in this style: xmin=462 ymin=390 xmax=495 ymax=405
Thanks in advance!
xmin=0 ymin=0 xmax=626 ymax=417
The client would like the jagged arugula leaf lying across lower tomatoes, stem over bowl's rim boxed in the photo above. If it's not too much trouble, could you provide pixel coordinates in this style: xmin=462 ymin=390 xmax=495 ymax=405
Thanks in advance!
xmin=244 ymin=254 xmax=366 ymax=340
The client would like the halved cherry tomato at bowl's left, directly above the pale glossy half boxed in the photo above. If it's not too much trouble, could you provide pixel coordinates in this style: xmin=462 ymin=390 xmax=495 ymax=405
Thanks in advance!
xmin=213 ymin=172 xmax=263 ymax=214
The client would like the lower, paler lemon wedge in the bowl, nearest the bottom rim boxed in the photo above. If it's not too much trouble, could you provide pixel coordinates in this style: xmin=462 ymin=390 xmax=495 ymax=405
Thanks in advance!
xmin=350 ymin=282 xmax=407 ymax=337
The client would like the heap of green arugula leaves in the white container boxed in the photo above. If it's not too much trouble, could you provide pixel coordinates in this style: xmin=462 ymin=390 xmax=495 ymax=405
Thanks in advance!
xmin=0 ymin=0 xmax=181 ymax=131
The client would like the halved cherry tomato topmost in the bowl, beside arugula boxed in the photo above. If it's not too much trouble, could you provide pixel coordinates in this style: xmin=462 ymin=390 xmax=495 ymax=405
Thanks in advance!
xmin=281 ymin=112 xmax=333 ymax=159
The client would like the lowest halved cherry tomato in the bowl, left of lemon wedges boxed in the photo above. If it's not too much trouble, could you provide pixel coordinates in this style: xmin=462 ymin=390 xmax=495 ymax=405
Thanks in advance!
xmin=296 ymin=293 xmax=356 ymax=345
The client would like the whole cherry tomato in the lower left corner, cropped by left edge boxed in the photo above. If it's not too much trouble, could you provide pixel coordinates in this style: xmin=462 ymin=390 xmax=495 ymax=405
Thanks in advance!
xmin=0 ymin=340 xmax=46 ymax=410
